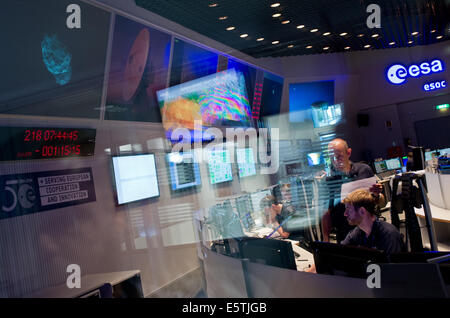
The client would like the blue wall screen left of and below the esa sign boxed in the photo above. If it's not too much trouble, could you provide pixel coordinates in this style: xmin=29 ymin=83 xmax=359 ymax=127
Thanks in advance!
xmin=289 ymin=81 xmax=342 ymax=127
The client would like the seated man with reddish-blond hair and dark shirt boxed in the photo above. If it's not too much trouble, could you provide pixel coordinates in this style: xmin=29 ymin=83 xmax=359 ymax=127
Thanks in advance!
xmin=341 ymin=189 xmax=405 ymax=254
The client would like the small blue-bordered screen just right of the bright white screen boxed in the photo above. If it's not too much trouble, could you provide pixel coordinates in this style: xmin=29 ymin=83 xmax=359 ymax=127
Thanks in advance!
xmin=167 ymin=152 xmax=201 ymax=191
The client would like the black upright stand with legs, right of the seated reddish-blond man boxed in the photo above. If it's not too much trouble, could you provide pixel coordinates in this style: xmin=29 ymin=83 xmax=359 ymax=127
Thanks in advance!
xmin=391 ymin=173 xmax=437 ymax=252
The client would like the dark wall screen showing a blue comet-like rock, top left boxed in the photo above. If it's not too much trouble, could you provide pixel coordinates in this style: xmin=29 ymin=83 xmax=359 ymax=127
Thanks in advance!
xmin=0 ymin=0 xmax=110 ymax=119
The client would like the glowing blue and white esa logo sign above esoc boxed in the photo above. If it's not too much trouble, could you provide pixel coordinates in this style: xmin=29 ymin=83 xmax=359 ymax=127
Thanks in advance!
xmin=386 ymin=59 xmax=444 ymax=85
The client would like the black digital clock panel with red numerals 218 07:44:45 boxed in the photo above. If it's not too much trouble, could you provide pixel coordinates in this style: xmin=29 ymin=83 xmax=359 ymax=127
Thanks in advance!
xmin=0 ymin=127 xmax=96 ymax=161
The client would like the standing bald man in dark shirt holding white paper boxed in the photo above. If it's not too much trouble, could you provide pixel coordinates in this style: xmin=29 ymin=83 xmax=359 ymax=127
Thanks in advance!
xmin=322 ymin=138 xmax=386 ymax=243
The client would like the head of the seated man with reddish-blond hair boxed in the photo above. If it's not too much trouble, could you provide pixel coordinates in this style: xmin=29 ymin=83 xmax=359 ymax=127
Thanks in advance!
xmin=342 ymin=189 xmax=377 ymax=225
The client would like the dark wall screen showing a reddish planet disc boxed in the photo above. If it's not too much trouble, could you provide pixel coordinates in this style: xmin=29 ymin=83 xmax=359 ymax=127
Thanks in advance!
xmin=105 ymin=16 xmax=171 ymax=122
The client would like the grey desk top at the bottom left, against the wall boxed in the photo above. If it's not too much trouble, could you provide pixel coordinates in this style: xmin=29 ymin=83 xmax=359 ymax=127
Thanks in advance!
xmin=27 ymin=270 xmax=142 ymax=298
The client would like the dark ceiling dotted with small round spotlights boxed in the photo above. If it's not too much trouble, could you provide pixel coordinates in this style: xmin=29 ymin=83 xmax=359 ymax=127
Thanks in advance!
xmin=135 ymin=0 xmax=450 ymax=58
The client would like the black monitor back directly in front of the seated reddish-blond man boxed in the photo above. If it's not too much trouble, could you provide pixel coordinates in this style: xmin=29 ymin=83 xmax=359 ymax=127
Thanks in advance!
xmin=311 ymin=241 xmax=388 ymax=278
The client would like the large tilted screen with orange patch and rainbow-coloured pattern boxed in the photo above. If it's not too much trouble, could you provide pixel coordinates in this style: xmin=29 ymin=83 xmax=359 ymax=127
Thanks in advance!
xmin=157 ymin=69 xmax=251 ymax=139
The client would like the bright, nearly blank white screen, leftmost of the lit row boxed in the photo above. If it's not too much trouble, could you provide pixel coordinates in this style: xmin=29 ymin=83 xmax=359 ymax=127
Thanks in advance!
xmin=112 ymin=154 xmax=159 ymax=205
